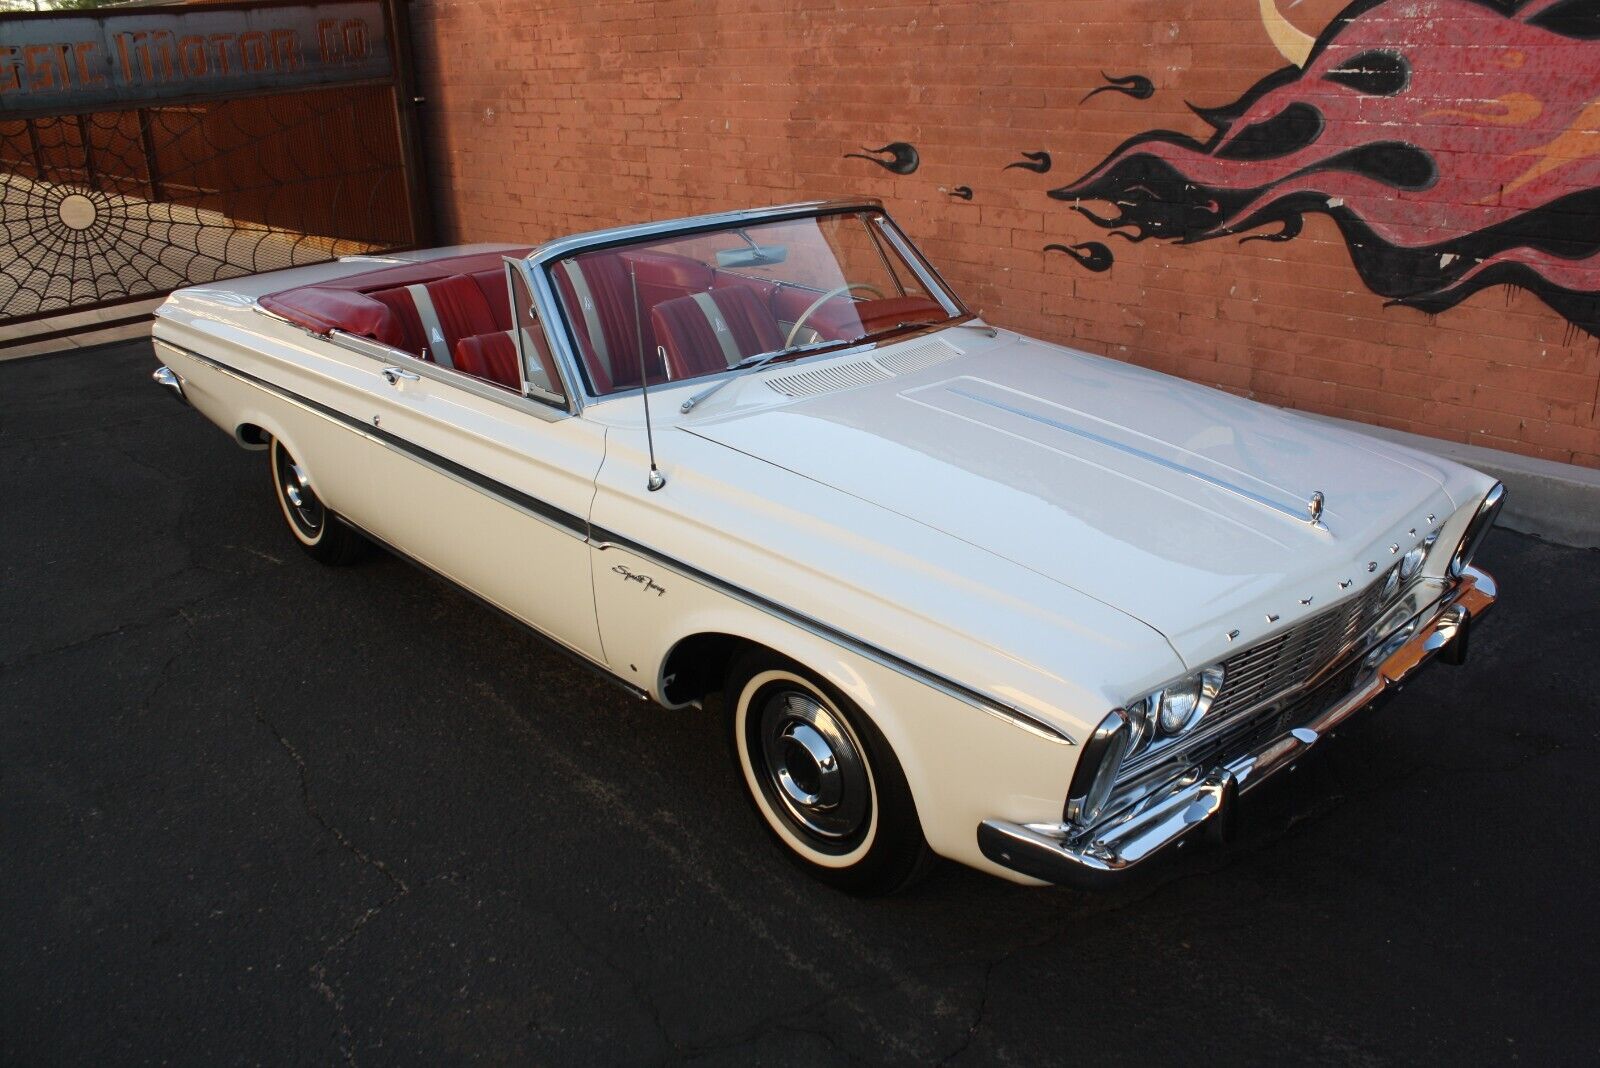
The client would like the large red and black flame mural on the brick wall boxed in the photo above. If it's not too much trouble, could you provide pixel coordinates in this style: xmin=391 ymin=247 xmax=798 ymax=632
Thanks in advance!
xmin=1050 ymin=0 xmax=1600 ymax=336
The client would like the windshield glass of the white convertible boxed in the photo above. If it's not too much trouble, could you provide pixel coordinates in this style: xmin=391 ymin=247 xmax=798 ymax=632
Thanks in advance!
xmin=550 ymin=211 xmax=966 ymax=395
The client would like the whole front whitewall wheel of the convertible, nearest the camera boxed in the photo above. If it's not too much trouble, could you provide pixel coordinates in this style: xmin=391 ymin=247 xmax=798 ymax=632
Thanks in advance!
xmin=726 ymin=651 xmax=933 ymax=894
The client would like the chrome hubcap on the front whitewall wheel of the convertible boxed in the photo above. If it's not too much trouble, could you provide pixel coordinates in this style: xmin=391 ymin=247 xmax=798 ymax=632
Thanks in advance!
xmin=757 ymin=689 xmax=872 ymax=843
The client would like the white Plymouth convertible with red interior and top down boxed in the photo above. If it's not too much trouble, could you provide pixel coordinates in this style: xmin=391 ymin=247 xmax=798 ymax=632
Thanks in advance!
xmin=155 ymin=201 xmax=1502 ymax=892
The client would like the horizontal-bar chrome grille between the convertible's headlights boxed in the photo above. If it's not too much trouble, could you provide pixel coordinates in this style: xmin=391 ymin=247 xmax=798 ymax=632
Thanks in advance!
xmin=1206 ymin=569 xmax=1400 ymax=721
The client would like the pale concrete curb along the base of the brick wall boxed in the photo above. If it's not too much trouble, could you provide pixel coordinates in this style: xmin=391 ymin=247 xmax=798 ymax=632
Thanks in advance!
xmin=1306 ymin=412 xmax=1600 ymax=548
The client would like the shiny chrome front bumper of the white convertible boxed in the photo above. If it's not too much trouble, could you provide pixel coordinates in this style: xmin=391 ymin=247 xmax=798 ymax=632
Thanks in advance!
xmin=978 ymin=568 xmax=1496 ymax=889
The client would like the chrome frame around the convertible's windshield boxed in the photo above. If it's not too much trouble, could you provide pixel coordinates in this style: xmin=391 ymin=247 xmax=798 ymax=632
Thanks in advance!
xmin=523 ymin=197 xmax=973 ymax=404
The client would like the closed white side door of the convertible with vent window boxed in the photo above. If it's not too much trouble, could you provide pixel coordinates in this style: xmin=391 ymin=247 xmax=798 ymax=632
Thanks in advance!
xmin=331 ymin=261 xmax=605 ymax=660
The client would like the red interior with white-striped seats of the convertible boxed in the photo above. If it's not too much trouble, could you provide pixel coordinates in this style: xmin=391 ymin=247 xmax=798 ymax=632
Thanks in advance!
xmin=261 ymin=249 xmax=944 ymax=393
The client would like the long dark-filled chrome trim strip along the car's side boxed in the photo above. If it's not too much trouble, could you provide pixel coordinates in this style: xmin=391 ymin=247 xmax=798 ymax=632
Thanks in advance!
xmin=157 ymin=339 xmax=1077 ymax=745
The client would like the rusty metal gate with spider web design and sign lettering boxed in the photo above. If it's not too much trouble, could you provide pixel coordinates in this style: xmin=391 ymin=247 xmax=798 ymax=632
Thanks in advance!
xmin=0 ymin=0 xmax=429 ymax=326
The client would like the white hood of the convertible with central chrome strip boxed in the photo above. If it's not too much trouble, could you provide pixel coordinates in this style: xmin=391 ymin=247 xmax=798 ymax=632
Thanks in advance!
xmin=683 ymin=336 xmax=1453 ymax=665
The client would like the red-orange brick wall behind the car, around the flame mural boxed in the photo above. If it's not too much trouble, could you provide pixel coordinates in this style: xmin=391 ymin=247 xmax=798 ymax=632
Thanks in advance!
xmin=410 ymin=0 xmax=1600 ymax=467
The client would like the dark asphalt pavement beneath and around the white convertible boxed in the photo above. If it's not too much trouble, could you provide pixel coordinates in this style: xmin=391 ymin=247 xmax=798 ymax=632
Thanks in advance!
xmin=9 ymin=342 xmax=1600 ymax=1065
